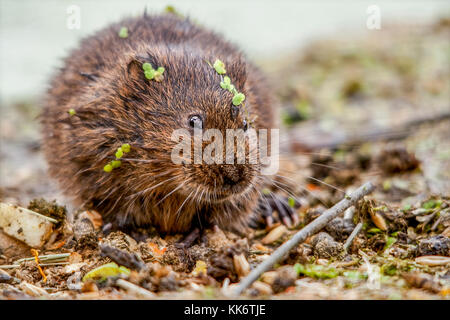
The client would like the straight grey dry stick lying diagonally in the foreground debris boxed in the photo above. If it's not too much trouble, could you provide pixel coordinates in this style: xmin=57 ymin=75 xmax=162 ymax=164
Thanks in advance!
xmin=234 ymin=182 xmax=375 ymax=295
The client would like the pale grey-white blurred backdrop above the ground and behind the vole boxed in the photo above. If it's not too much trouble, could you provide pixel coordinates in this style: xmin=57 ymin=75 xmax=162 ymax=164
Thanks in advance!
xmin=0 ymin=0 xmax=450 ymax=101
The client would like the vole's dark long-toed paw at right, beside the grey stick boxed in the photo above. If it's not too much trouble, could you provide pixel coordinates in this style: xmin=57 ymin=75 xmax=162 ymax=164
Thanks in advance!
xmin=249 ymin=192 xmax=301 ymax=228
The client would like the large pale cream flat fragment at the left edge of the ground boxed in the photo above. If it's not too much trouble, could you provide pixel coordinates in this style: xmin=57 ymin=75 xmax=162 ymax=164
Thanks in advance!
xmin=0 ymin=203 xmax=58 ymax=248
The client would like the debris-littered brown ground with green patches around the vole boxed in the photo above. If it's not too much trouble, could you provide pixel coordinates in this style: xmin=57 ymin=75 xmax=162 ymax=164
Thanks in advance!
xmin=0 ymin=19 xmax=450 ymax=299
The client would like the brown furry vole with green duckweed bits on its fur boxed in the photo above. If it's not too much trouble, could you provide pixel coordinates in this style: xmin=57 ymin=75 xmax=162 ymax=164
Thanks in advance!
xmin=42 ymin=14 xmax=275 ymax=233
